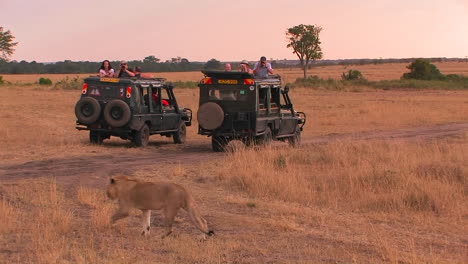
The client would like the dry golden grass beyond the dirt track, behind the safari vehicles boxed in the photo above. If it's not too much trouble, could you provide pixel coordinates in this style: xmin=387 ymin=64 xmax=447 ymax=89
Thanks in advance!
xmin=0 ymin=80 xmax=468 ymax=161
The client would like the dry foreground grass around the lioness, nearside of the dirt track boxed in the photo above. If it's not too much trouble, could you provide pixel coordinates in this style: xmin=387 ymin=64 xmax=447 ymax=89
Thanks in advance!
xmin=0 ymin=137 xmax=468 ymax=263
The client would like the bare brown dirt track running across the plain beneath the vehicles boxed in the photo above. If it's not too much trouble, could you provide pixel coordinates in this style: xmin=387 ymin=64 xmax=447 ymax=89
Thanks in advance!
xmin=0 ymin=123 xmax=468 ymax=185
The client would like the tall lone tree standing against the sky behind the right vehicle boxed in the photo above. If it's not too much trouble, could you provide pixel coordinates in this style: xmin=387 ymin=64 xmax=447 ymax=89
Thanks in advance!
xmin=286 ymin=24 xmax=323 ymax=79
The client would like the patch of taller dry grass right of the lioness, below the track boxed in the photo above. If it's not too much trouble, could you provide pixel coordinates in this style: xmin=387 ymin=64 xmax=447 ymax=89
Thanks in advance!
xmin=219 ymin=141 xmax=468 ymax=217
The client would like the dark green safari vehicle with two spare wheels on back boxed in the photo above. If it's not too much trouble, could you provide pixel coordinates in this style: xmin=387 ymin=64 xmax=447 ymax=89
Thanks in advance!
xmin=75 ymin=77 xmax=192 ymax=147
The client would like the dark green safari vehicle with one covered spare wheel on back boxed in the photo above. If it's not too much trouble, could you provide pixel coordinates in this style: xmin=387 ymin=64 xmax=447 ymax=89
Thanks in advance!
xmin=197 ymin=71 xmax=306 ymax=152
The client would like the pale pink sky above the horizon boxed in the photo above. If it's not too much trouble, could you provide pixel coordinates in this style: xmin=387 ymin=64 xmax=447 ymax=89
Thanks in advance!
xmin=0 ymin=0 xmax=468 ymax=62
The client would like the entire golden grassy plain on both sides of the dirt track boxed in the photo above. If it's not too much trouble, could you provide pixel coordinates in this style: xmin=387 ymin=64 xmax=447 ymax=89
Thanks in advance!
xmin=0 ymin=64 xmax=468 ymax=263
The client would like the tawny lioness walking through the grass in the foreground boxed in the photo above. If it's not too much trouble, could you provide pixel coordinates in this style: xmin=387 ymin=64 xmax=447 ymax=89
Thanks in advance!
xmin=107 ymin=175 xmax=214 ymax=237
